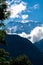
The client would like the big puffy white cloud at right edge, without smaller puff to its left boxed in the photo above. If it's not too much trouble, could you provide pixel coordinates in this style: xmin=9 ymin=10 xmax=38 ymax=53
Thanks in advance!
xmin=30 ymin=26 xmax=43 ymax=43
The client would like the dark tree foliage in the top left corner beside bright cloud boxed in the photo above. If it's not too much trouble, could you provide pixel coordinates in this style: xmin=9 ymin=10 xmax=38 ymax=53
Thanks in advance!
xmin=0 ymin=0 xmax=10 ymax=20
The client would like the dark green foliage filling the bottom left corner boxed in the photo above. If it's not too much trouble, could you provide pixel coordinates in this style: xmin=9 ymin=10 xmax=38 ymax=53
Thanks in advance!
xmin=0 ymin=48 xmax=9 ymax=65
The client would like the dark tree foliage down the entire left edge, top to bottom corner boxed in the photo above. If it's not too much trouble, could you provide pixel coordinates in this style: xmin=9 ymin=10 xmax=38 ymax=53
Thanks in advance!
xmin=0 ymin=0 xmax=10 ymax=65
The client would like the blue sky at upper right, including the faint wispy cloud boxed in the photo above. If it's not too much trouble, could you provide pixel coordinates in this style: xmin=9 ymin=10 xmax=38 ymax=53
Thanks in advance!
xmin=8 ymin=0 xmax=43 ymax=22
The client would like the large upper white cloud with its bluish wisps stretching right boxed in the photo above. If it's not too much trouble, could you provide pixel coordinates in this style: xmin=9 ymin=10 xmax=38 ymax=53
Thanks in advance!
xmin=7 ymin=0 xmax=39 ymax=23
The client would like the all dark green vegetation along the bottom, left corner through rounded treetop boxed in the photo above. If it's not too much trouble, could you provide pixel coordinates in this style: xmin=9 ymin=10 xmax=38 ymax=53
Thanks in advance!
xmin=0 ymin=49 xmax=32 ymax=65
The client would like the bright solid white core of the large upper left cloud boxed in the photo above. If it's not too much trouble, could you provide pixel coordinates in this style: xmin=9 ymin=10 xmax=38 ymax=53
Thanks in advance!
xmin=8 ymin=2 xmax=26 ymax=18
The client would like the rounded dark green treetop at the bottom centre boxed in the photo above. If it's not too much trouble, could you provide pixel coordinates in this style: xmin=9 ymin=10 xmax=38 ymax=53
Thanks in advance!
xmin=10 ymin=55 xmax=32 ymax=65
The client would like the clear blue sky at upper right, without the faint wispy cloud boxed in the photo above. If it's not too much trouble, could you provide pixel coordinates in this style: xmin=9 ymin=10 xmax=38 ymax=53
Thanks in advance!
xmin=24 ymin=0 xmax=43 ymax=22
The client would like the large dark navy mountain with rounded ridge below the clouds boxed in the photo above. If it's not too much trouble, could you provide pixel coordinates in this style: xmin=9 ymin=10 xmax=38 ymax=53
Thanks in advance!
xmin=0 ymin=35 xmax=43 ymax=65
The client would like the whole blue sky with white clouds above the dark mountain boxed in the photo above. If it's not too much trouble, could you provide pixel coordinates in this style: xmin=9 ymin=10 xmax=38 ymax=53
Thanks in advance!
xmin=4 ymin=0 xmax=43 ymax=43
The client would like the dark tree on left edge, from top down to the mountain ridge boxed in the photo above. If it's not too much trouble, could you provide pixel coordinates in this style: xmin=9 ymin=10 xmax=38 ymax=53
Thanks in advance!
xmin=0 ymin=0 xmax=10 ymax=43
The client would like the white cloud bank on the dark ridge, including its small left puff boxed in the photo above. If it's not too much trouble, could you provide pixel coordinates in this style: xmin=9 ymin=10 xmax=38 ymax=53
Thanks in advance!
xmin=19 ymin=26 xmax=43 ymax=43
